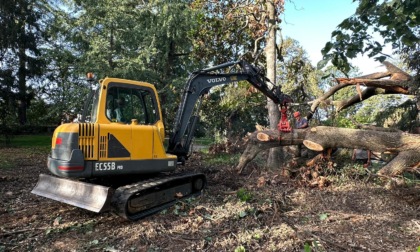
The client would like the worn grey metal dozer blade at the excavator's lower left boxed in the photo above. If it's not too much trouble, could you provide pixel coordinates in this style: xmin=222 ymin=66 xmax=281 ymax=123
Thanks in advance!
xmin=32 ymin=174 xmax=112 ymax=213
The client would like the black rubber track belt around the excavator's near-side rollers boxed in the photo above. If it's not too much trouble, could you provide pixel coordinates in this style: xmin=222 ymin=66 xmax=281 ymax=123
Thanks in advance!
xmin=111 ymin=173 xmax=206 ymax=221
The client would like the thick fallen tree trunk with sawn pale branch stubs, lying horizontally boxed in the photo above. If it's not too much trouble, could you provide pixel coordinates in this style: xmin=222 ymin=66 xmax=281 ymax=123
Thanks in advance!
xmin=236 ymin=126 xmax=420 ymax=176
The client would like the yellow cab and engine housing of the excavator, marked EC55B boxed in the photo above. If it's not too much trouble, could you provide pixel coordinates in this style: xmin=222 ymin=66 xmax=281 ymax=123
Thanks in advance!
xmin=44 ymin=78 xmax=177 ymax=178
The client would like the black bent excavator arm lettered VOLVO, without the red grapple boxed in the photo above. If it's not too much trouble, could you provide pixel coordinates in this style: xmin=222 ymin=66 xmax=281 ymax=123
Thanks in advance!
xmin=167 ymin=61 xmax=292 ymax=164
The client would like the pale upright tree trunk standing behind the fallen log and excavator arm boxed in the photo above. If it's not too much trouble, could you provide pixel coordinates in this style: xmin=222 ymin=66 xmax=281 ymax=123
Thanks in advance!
xmin=265 ymin=1 xmax=284 ymax=169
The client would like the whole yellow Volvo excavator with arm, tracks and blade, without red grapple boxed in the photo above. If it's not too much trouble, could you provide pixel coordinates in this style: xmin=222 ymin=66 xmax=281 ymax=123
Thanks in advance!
xmin=32 ymin=61 xmax=291 ymax=220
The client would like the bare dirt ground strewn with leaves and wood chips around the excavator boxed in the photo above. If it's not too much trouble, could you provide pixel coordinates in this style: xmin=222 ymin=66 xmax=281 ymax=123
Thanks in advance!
xmin=0 ymin=149 xmax=420 ymax=252
